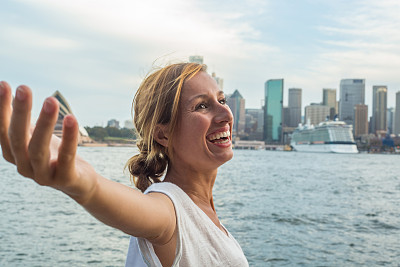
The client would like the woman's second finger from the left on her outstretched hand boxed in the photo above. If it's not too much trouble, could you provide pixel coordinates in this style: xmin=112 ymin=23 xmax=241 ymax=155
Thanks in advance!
xmin=8 ymin=85 xmax=33 ymax=177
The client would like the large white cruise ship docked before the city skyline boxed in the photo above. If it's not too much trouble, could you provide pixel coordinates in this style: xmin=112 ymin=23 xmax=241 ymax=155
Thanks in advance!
xmin=290 ymin=121 xmax=358 ymax=153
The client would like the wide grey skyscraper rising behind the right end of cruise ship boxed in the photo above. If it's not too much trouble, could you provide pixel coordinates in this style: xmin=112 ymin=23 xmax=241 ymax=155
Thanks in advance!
xmin=339 ymin=79 xmax=365 ymax=126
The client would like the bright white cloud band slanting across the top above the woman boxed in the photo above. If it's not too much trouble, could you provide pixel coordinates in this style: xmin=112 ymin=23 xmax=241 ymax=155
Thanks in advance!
xmin=22 ymin=0 xmax=276 ymax=57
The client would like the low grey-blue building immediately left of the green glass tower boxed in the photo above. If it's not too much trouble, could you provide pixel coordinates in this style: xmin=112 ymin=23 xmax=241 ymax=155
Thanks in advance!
xmin=245 ymin=109 xmax=264 ymax=141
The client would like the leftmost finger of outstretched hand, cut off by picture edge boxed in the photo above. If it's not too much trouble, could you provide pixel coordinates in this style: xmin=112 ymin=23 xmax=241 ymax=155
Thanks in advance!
xmin=0 ymin=82 xmax=15 ymax=163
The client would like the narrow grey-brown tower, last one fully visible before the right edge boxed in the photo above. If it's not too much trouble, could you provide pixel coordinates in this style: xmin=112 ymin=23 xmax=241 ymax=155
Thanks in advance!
xmin=371 ymin=85 xmax=387 ymax=134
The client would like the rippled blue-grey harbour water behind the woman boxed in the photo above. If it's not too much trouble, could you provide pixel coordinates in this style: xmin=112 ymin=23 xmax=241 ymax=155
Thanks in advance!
xmin=0 ymin=150 xmax=400 ymax=266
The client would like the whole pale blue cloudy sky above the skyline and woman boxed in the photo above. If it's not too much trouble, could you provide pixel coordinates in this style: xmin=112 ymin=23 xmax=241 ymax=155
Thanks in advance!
xmin=0 ymin=0 xmax=400 ymax=126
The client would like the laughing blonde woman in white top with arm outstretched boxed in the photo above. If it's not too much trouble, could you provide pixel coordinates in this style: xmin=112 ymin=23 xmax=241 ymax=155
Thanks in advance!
xmin=0 ymin=63 xmax=248 ymax=266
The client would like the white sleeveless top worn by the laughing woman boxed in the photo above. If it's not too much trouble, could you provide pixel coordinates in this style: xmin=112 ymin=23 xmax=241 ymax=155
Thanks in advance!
xmin=125 ymin=182 xmax=249 ymax=267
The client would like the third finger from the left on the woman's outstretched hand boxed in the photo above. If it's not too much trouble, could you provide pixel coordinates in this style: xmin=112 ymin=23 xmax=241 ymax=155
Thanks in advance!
xmin=28 ymin=97 xmax=58 ymax=185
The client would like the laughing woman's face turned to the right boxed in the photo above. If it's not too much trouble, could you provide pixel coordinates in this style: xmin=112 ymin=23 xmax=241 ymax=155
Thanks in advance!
xmin=172 ymin=71 xmax=233 ymax=172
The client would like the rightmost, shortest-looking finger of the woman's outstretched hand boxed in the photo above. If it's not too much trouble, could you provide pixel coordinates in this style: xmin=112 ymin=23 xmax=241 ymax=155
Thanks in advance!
xmin=58 ymin=115 xmax=79 ymax=171
